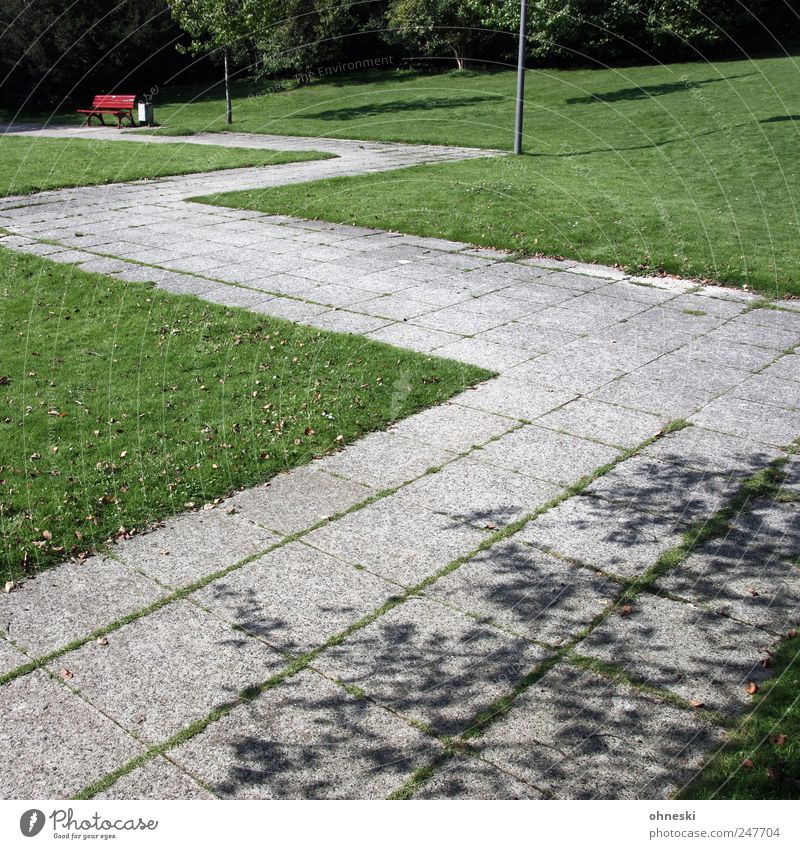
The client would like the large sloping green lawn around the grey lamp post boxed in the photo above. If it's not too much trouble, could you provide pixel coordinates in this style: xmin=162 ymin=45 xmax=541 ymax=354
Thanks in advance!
xmin=119 ymin=56 xmax=800 ymax=296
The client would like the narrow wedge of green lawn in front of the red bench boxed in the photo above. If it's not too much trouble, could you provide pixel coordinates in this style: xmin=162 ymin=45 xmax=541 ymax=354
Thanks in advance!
xmin=0 ymin=135 xmax=332 ymax=197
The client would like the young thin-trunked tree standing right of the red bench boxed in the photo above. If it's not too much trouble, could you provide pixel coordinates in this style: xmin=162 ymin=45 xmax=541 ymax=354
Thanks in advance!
xmin=167 ymin=0 xmax=262 ymax=124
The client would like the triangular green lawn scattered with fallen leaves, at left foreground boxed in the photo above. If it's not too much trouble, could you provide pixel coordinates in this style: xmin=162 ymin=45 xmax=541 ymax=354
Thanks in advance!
xmin=0 ymin=249 xmax=489 ymax=580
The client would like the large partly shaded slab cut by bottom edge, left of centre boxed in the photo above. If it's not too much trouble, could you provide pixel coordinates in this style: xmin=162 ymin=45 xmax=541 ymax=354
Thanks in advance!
xmin=165 ymin=670 xmax=438 ymax=799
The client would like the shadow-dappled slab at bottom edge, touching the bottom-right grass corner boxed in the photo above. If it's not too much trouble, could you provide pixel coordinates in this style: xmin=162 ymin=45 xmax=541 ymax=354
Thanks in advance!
xmin=477 ymin=664 xmax=722 ymax=799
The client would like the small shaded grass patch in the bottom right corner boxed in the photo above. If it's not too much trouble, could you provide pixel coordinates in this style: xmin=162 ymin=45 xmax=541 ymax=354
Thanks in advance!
xmin=681 ymin=637 xmax=800 ymax=799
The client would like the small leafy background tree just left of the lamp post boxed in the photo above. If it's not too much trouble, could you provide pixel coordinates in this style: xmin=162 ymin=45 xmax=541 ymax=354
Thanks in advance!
xmin=386 ymin=0 xmax=482 ymax=69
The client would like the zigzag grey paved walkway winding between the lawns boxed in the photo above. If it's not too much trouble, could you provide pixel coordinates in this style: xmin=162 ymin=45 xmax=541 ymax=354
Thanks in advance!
xmin=0 ymin=129 xmax=800 ymax=798
